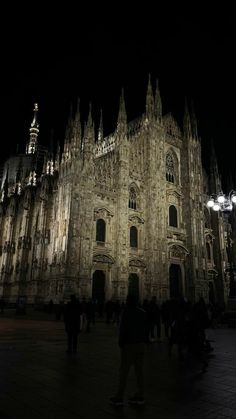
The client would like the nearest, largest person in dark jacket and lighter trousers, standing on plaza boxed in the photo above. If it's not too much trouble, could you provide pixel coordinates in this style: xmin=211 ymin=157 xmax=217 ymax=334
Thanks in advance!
xmin=110 ymin=294 xmax=148 ymax=406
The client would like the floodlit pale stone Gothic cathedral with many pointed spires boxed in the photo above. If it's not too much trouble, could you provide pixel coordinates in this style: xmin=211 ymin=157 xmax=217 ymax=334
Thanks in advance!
xmin=0 ymin=80 xmax=232 ymax=304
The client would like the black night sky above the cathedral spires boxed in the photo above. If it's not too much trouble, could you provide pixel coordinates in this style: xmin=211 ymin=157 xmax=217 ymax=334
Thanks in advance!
xmin=0 ymin=1 xmax=236 ymax=182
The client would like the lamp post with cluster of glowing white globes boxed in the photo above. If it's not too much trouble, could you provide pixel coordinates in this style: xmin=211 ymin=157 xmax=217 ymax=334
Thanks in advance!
xmin=207 ymin=190 xmax=236 ymax=297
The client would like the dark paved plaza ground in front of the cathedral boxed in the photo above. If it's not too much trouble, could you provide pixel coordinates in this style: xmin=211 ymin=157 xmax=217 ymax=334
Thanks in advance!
xmin=0 ymin=312 xmax=236 ymax=419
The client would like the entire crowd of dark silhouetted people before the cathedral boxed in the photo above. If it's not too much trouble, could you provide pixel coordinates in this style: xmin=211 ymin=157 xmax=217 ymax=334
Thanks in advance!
xmin=0 ymin=294 xmax=224 ymax=406
